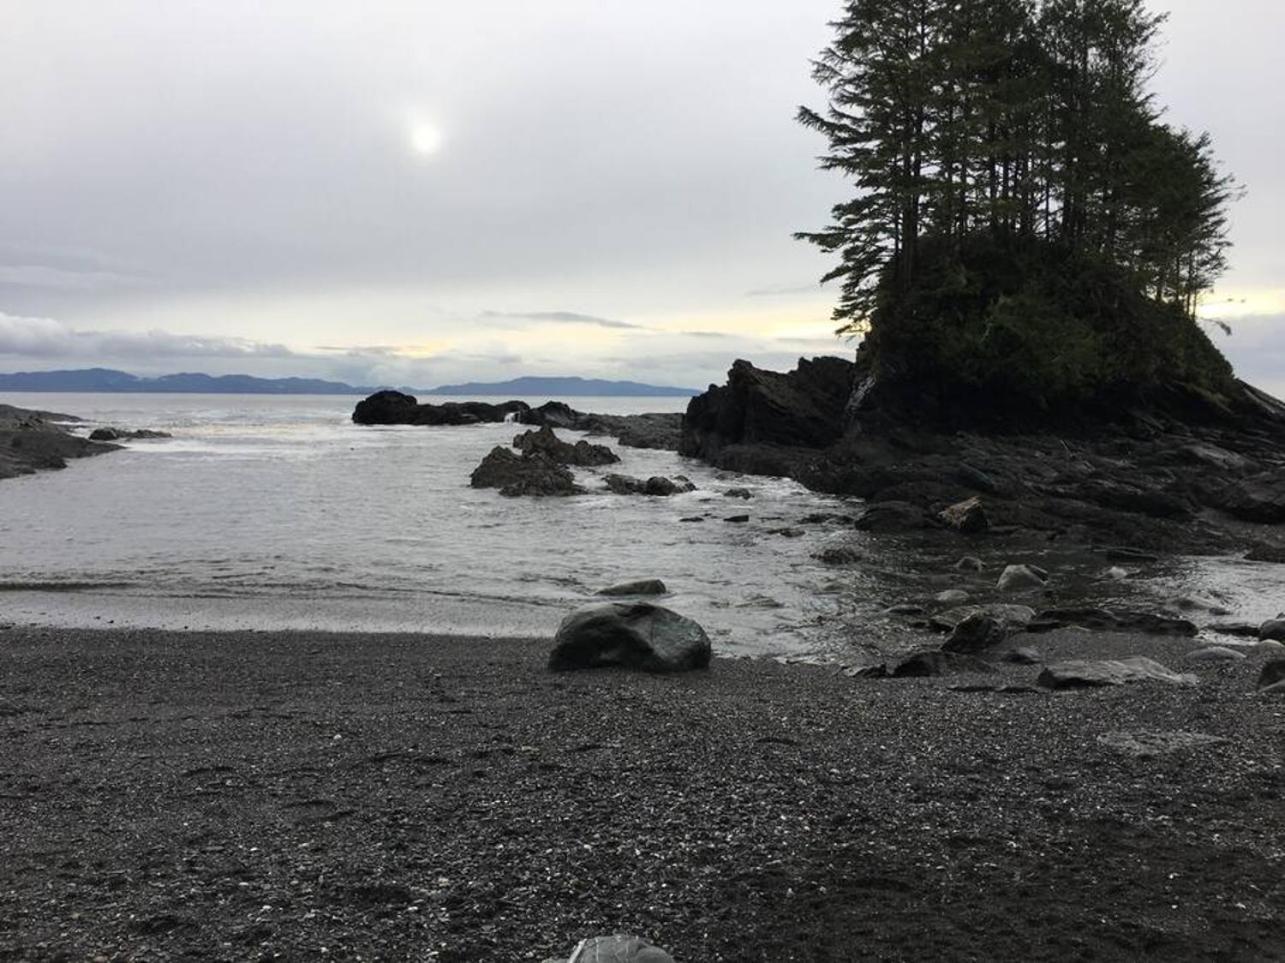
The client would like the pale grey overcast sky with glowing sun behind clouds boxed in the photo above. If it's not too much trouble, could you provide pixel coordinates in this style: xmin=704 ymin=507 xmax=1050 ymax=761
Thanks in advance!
xmin=0 ymin=0 xmax=1285 ymax=390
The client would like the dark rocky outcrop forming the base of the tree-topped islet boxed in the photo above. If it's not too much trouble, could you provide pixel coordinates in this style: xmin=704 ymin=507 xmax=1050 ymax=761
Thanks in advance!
xmin=681 ymin=359 xmax=1285 ymax=559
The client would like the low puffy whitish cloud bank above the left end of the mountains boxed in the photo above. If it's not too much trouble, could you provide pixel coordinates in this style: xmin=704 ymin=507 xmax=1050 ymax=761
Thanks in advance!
xmin=0 ymin=314 xmax=296 ymax=363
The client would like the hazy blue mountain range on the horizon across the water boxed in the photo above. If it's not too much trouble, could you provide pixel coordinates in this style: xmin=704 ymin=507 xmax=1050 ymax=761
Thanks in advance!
xmin=0 ymin=368 xmax=700 ymax=397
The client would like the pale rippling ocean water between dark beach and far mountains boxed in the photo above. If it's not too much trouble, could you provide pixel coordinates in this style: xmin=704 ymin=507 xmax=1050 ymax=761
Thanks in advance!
xmin=0 ymin=393 xmax=858 ymax=656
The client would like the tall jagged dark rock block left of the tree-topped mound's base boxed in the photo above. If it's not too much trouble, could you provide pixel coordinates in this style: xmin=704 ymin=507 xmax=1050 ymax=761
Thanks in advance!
xmin=678 ymin=357 xmax=856 ymax=463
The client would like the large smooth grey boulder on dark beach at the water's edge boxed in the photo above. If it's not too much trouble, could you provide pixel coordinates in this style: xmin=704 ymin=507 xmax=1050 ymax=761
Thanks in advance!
xmin=549 ymin=602 xmax=712 ymax=672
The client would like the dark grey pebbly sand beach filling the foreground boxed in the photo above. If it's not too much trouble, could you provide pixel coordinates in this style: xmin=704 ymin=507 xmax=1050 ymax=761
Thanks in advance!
xmin=0 ymin=629 xmax=1285 ymax=963
